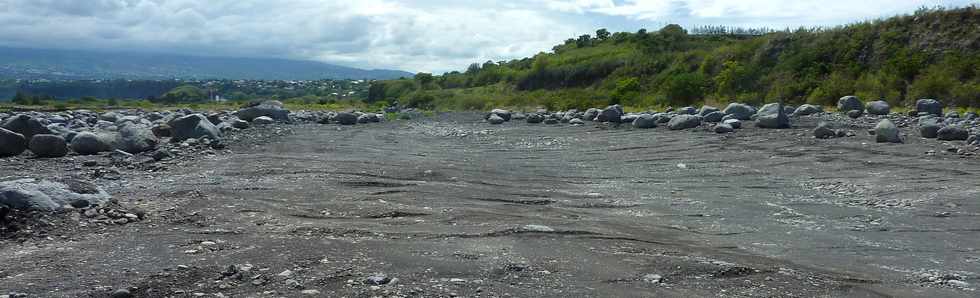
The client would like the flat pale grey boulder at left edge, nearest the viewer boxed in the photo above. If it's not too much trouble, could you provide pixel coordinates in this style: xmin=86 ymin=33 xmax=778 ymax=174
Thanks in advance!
xmin=0 ymin=179 xmax=112 ymax=211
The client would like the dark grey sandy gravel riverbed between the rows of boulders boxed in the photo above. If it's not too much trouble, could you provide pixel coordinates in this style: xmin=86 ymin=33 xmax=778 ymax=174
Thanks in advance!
xmin=0 ymin=114 xmax=980 ymax=297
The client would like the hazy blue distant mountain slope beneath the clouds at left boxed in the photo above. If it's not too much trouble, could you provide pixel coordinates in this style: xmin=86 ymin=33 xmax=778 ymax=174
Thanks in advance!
xmin=0 ymin=47 xmax=413 ymax=80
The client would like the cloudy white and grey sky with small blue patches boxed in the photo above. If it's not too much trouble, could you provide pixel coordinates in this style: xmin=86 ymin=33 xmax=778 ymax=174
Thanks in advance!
xmin=0 ymin=0 xmax=980 ymax=73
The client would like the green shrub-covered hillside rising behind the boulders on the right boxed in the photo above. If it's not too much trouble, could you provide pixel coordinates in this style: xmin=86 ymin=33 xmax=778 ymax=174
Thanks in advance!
xmin=368 ymin=5 xmax=980 ymax=109
